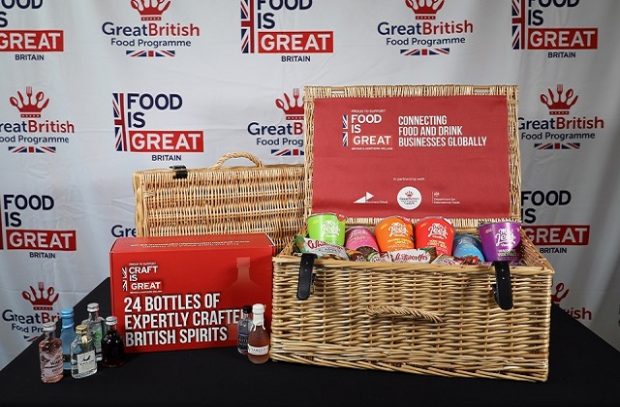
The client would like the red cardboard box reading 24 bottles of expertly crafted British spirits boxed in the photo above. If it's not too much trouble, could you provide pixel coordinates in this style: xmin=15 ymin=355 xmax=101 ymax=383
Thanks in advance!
xmin=110 ymin=233 xmax=274 ymax=352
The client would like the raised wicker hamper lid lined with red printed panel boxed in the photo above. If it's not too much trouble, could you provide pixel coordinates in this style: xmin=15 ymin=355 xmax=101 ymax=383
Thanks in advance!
xmin=304 ymin=85 xmax=521 ymax=227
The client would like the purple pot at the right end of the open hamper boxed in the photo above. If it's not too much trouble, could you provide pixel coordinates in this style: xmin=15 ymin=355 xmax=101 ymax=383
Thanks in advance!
xmin=478 ymin=221 xmax=521 ymax=264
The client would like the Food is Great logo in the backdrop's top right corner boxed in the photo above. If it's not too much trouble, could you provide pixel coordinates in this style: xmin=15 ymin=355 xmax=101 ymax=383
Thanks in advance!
xmin=512 ymin=0 xmax=598 ymax=58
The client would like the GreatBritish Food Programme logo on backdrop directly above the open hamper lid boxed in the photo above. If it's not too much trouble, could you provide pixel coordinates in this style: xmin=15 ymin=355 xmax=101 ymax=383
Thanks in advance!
xmin=377 ymin=0 xmax=474 ymax=57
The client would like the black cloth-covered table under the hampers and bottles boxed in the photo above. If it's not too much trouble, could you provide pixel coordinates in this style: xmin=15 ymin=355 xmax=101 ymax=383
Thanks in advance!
xmin=0 ymin=279 xmax=620 ymax=407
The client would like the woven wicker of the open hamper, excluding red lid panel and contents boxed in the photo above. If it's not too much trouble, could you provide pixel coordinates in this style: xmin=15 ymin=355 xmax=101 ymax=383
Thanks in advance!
xmin=271 ymin=85 xmax=553 ymax=381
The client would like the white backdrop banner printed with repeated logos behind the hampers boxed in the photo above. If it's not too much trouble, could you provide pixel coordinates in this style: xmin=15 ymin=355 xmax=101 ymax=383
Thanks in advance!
xmin=0 ymin=0 xmax=620 ymax=367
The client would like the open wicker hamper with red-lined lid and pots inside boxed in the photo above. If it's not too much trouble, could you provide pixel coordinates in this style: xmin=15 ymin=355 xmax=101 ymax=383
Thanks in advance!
xmin=270 ymin=85 xmax=554 ymax=381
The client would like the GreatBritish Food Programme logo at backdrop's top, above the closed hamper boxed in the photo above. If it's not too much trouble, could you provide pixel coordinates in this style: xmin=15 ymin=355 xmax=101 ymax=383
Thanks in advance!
xmin=101 ymin=0 xmax=201 ymax=59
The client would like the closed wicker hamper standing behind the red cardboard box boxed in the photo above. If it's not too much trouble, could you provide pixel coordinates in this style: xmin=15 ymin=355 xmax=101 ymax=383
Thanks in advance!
xmin=133 ymin=153 xmax=304 ymax=250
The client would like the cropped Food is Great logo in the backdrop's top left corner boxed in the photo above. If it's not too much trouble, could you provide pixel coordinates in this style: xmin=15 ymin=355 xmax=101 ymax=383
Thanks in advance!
xmin=0 ymin=0 xmax=65 ymax=61
